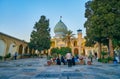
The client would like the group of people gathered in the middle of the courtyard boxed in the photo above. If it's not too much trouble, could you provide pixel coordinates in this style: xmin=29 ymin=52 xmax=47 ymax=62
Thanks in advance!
xmin=50 ymin=53 xmax=97 ymax=67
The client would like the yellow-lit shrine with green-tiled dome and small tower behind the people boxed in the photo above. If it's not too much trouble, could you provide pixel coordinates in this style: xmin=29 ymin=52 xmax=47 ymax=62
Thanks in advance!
xmin=51 ymin=20 xmax=94 ymax=56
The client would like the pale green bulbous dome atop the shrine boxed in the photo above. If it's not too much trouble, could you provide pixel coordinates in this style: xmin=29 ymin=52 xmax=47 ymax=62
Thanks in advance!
xmin=54 ymin=20 xmax=67 ymax=34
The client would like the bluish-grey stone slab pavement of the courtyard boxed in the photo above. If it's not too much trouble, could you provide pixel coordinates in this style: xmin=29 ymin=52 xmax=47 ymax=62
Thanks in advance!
xmin=0 ymin=58 xmax=120 ymax=79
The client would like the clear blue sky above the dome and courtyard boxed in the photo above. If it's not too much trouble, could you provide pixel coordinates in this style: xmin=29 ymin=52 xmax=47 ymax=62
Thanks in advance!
xmin=0 ymin=0 xmax=88 ymax=42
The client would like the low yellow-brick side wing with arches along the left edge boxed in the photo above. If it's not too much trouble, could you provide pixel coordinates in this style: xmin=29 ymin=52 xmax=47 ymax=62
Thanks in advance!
xmin=0 ymin=32 xmax=30 ymax=56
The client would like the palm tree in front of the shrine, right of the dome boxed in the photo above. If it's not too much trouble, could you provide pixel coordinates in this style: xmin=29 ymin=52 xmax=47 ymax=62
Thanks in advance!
xmin=63 ymin=30 xmax=75 ymax=47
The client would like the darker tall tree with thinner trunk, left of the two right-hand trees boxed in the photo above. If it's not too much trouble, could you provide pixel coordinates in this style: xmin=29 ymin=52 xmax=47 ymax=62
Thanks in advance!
xmin=84 ymin=1 xmax=102 ymax=58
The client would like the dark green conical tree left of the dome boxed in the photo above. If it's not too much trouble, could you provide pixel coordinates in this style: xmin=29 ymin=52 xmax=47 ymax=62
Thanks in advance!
xmin=29 ymin=15 xmax=51 ymax=51
